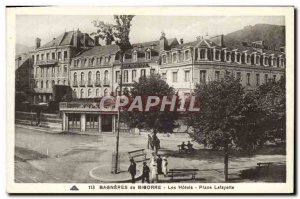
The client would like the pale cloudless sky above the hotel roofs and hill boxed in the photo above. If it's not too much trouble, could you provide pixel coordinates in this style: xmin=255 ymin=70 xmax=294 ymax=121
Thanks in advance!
xmin=16 ymin=15 xmax=285 ymax=46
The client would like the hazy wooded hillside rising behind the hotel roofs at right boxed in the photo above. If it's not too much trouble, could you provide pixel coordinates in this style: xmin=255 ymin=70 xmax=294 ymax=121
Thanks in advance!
xmin=224 ymin=24 xmax=285 ymax=48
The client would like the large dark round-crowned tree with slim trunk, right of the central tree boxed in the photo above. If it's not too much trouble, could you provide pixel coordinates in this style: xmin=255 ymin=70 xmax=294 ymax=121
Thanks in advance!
xmin=186 ymin=76 xmax=264 ymax=181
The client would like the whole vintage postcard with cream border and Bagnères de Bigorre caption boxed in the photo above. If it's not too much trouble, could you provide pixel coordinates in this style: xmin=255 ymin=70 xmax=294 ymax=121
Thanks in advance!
xmin=6 ymin=6 xmax=295 ymax=194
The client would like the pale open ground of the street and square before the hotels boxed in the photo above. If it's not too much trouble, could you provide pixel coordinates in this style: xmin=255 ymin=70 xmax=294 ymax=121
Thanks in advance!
xmin=15 ymin=126 xmax=285 ymax=183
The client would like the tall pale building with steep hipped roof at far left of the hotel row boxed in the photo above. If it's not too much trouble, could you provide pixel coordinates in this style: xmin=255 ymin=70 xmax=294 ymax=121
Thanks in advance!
xmin=30 ymin=30 xmax=94 ymax=103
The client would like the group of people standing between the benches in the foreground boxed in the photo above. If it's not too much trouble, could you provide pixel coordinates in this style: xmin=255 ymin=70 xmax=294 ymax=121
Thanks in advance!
xmin=128 ymin=152 xmax=168 ymax=183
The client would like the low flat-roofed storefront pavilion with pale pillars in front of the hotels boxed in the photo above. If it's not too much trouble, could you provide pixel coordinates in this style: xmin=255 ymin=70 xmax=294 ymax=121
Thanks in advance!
xmin=59 ymin=102 xmax=117 ymax=133
